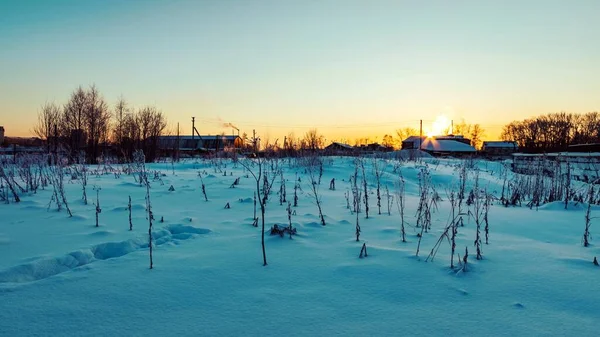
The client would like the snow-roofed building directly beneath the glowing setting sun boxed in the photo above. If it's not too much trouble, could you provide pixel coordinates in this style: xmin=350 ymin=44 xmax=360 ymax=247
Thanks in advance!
xmin=402 ymin=135 xmax=477 ymax=156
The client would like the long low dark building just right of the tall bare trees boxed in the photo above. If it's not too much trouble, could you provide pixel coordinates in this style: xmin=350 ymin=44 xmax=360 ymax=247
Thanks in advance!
xmin=158 ymin=135 xmax=244 ymax=154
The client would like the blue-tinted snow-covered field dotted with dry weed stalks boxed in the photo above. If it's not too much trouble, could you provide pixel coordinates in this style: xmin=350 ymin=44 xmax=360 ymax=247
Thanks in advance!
xmin=0 ymin=158 xmax=600 ymax=336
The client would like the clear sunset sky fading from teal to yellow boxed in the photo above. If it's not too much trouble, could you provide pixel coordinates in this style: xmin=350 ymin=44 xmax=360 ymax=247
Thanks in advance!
xmin=0 ymin=0 xmax=600 ymax=142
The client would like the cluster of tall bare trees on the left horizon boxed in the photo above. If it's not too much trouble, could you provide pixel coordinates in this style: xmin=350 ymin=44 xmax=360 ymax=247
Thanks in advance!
xmin=33 ymin=85 xmax=167 ymax=164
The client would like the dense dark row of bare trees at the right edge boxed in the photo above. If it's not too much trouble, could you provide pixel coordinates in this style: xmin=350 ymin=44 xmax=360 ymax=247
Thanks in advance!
xmin=500 ymin=112 xmax=600 ymax=153
